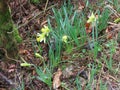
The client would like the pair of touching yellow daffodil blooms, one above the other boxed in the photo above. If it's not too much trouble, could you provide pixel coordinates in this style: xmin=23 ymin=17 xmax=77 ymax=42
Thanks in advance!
xmin=36 ymin=26 xmax=50 ymax=43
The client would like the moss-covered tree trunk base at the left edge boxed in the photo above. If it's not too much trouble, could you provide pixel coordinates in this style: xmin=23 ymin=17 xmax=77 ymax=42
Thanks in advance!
xmin=0 ymin=0 xmax=22 ymax=58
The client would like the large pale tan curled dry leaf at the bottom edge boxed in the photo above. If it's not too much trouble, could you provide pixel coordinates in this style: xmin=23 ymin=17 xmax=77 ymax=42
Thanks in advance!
xmin=53 ymin=68 xmax=62 ymax=90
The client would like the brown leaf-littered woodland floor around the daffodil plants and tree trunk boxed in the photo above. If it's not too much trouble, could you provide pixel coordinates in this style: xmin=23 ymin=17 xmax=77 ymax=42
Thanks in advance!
xmin=0 ymin=0 xmax=120 ymax=90
